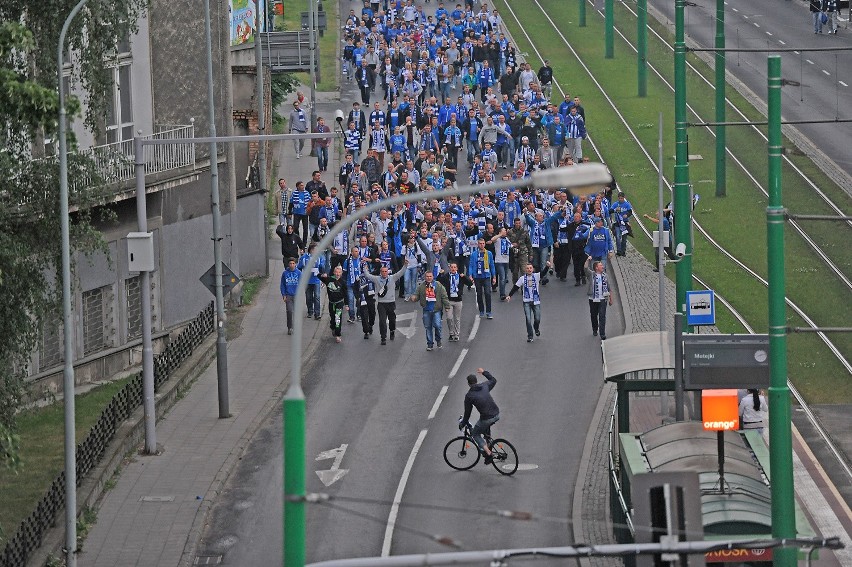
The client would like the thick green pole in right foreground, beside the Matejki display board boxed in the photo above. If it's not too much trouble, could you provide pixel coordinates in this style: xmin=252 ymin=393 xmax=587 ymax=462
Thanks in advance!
xmin=766 ymin=55 xmax=797 ymax=567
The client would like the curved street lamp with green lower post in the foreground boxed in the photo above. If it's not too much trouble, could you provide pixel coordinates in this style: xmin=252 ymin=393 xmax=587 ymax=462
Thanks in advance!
xmin=283 ymin=163 xmax=612 ymax=567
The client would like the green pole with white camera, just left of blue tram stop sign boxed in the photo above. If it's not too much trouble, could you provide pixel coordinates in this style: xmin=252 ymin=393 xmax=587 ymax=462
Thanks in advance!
xmin=676 ymin=0 xmax=692 ymax=324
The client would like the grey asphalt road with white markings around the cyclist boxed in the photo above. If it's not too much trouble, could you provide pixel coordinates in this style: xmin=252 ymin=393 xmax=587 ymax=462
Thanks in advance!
xmin=202 ymin=260 xmax=623 ymax=565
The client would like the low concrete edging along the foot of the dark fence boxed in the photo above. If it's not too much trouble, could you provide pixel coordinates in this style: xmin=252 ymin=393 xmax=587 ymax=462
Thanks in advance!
xmin=32 ymin=333 xmax=216 ymax=566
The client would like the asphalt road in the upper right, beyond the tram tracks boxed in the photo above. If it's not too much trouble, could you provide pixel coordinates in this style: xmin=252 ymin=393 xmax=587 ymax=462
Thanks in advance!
xmin=649 ymin=0 xmax=852 ymax=179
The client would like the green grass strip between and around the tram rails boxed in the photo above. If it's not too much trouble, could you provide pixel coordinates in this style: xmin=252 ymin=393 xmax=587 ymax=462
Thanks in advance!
xmin=495 ymin=0 xmax=852 ymax=403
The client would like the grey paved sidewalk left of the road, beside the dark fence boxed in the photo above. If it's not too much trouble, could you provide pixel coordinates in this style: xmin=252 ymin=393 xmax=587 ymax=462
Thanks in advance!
xmin=78 ymin=117 xmax=337 ymax=567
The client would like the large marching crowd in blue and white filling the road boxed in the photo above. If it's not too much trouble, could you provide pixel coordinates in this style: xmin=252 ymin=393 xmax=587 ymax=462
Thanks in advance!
xmin=277 ymin=0 xmax=652 ymax=350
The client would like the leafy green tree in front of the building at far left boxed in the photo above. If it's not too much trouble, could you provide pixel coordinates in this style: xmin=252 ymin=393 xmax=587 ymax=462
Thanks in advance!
xmin=0 ymin=0 xmax=146 ymax=452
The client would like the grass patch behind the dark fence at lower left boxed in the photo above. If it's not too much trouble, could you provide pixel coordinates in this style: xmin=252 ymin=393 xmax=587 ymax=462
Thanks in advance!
xmin=0 ymin=378 xmax=129 ymax=537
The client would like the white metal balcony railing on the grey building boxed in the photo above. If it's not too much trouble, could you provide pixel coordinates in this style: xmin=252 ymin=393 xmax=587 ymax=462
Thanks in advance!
xmin=81 ymin=124 xmax=195 ymax=187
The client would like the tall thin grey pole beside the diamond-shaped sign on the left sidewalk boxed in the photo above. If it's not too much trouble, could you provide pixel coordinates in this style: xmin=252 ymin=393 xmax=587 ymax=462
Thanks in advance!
xmin=204 ymin=0 xmax=231 ymax=419
